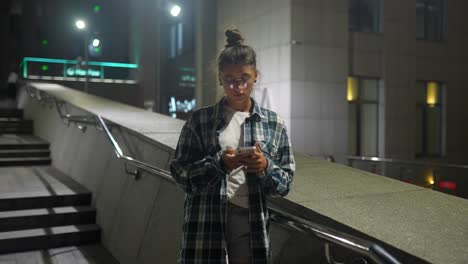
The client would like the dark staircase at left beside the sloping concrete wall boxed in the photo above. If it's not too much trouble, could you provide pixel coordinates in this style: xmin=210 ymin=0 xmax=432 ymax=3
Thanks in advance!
xmin=0 ymin=109 xmax=101 ymax=254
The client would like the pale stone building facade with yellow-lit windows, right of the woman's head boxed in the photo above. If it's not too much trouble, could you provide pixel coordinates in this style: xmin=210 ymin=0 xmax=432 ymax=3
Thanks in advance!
xmin=213 ymin=0 xmax=468 ymax=162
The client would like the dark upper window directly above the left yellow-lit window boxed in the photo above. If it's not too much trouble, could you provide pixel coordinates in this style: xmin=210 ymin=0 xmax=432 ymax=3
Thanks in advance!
xmin=349 ymin=0 xmax=381 ymax=32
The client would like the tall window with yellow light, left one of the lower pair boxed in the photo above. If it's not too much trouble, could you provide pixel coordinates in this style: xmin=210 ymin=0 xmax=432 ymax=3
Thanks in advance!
xmin=348 ymin=77 xmax=379 ymax=157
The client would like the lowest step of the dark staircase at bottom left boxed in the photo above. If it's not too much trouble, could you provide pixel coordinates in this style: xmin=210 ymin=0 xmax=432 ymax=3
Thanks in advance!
xmin=0 ymin=224 xmax=101 ymax=254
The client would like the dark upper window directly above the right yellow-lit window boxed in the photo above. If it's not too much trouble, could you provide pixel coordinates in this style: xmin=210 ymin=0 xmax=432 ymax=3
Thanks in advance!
xmin=416 ymin=0 xmax=446 ymax=41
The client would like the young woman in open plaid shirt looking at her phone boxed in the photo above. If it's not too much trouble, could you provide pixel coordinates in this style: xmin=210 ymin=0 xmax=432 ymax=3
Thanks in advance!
xmin=171 ymin=29 xmax=295 ymax=264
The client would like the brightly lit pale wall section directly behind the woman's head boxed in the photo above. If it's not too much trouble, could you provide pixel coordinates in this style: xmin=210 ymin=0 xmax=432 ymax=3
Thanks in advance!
xmin=217 ymin=0 xmax=292 ymax=129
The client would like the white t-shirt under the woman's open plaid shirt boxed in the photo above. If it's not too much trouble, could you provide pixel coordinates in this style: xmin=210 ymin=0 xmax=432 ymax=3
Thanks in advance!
xmin=219 ymin=106 xmax=250 ymax=208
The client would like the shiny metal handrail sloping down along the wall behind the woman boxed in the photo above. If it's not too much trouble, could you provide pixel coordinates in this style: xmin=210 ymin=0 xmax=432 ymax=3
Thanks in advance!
xmin=24 ymin=85 xmax=400 ymax=264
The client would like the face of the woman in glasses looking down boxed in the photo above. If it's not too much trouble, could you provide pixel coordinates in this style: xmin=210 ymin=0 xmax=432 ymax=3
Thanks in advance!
xmin=219 ymin=64 xmax=258 ymax=111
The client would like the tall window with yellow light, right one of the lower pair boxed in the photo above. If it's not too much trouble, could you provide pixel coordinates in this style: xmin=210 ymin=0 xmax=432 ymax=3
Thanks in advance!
xmin=415 ymin=81 xmax=444 ymax=157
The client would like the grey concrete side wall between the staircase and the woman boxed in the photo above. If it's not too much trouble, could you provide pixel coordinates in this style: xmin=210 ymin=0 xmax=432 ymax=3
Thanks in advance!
xmin=24 ymin=95 xmax=184 ymax=264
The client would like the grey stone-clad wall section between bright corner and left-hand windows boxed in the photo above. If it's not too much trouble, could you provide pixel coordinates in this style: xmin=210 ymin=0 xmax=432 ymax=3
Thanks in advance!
xmin=291 ymin=0 xmax=348 ymax=162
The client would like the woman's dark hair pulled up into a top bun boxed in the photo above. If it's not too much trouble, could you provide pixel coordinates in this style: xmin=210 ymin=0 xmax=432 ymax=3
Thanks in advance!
xmin=218 ymin=29 xmax=257 ymax=72
